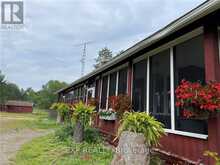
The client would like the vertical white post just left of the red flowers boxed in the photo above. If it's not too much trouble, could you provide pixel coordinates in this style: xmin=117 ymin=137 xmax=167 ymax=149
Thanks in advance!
xmin=170 ymin=47 xmax=175 ymax=130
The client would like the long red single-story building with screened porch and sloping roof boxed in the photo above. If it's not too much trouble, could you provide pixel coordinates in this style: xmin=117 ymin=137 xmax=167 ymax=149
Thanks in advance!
xmin=58 ymin=0 xmax=220 ymax=164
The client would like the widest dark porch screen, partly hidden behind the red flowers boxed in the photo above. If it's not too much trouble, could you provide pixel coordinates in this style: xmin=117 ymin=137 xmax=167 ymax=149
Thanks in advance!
xmin=174 ymin=36 xmax=208 ymax=134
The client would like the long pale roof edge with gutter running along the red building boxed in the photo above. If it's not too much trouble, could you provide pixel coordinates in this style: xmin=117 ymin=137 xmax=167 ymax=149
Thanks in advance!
xmin=57 ymin=0 xmax=220 ymax=93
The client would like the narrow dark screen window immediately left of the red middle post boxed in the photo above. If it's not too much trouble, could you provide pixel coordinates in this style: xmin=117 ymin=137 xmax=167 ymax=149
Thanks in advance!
xmin=118 ymin=68 xmax=127 ymax=95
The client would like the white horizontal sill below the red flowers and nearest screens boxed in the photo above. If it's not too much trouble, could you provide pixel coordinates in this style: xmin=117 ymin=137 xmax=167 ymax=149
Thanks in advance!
xmin=165 ymin=129 xmax=208 ymax=140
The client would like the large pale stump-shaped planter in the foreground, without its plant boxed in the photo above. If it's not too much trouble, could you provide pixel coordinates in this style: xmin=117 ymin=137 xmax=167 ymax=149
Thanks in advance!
xmin=111 ymin=131 xmax=150 ymax=165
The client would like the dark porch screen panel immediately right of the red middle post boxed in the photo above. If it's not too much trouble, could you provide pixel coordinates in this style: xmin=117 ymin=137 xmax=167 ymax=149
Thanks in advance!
xmin=132 ymin=60 xmax=147 ymax=112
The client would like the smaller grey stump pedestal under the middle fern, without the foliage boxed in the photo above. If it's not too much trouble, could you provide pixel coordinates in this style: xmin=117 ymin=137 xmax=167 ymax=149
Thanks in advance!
xmin=73 ymin=121 xmax=84 ymax=143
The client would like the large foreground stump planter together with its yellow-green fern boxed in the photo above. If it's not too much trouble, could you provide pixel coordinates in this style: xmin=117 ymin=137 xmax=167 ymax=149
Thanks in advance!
xmin=111 ymin=112 xmax=165 ymax=165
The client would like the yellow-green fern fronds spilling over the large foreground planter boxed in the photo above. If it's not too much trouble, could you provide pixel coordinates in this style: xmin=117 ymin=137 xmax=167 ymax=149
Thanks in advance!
xmin=118 ymin=112 xmax=165 ymax=147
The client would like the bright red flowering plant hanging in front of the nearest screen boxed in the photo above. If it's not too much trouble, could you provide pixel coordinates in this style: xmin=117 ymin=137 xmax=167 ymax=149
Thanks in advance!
xmin=175 ymin=80 xmax=220 ymax=118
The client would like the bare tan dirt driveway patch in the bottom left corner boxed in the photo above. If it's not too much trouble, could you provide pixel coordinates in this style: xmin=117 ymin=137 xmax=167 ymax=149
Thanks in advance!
xmin=0 ymin=129 xmax=51 ymax=165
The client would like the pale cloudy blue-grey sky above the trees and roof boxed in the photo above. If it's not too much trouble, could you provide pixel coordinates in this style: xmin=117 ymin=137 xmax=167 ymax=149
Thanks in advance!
xmin=0 ymin=0 xmax=204 ymax=90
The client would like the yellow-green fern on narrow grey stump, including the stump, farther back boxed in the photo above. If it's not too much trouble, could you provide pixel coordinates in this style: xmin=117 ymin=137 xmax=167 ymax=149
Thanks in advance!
xmin=72 ymin=101 xmax=95 ymax=143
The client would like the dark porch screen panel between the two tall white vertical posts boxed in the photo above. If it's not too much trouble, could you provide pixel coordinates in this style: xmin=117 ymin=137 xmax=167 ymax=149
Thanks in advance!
xmin=149 ymin=50 xmax=171 ymax=129
